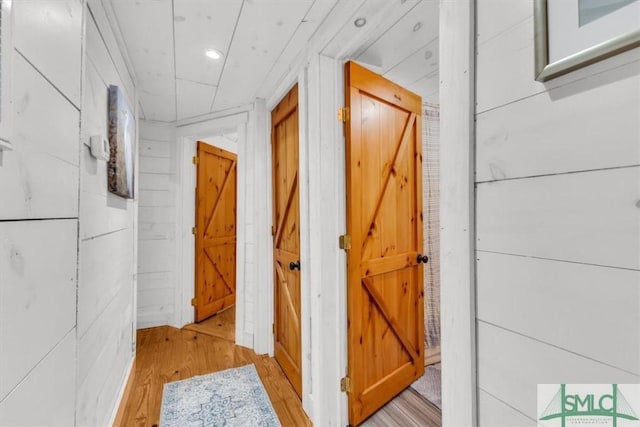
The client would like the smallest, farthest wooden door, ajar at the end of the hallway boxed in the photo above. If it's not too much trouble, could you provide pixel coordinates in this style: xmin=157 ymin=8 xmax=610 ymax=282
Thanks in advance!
xmin=194 ymin=141 xmax=237 ymax=322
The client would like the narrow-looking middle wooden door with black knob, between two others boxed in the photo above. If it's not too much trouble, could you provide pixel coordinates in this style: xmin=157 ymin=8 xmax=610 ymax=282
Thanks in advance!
xmin=271 ymin=85 xmax=302 ymax=396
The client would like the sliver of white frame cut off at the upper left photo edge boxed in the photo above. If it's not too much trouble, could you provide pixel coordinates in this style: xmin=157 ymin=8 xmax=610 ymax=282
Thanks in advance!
xmin=0 ymin=0 xmax=13 ymax=151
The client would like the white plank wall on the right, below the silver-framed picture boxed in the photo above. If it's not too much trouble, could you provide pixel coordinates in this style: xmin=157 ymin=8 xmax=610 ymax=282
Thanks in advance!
xmin=475 ymin=0 xmax=640 ymax=426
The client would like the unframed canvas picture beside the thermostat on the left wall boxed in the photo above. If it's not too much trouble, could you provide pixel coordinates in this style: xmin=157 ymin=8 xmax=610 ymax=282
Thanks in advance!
xmin=107 ymin=85 xmax=136 ymax=199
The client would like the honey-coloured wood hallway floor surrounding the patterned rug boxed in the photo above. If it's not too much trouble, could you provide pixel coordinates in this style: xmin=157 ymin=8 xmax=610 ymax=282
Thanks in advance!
xmin=114 ymin=326 xmax=311 ymax=427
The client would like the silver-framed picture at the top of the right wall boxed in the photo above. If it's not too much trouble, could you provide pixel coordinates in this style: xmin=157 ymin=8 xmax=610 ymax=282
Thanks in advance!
xmin=534 ymin=0 xmax=640 ymax=82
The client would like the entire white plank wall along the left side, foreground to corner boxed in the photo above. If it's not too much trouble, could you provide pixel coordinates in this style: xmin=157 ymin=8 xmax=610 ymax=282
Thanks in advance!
xmin=0 ymin=0 xmax=136 ymax=426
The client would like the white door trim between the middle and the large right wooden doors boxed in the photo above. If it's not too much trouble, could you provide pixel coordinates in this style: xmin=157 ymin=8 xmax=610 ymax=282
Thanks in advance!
xmin=298 ymin=54 xmax=348 ymax=426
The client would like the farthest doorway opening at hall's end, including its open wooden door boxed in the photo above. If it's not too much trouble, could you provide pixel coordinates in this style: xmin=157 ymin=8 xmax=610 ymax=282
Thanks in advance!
xmin=186 ymin=132 xmax=238 ymax=342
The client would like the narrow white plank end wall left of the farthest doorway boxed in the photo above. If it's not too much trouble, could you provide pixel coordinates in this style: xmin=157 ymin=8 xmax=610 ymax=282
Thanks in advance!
xmin=137 ymin=121 xmax=181 ymax=329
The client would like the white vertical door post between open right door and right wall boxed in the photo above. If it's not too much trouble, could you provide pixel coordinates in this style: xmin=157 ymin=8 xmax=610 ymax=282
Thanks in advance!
xmin=439 ymin=0 xmax=478 ymax=427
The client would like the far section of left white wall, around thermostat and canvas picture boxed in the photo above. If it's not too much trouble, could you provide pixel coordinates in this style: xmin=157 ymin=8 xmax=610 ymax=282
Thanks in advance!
xmin=76 ymin=0 xmax=139 ymax=426
